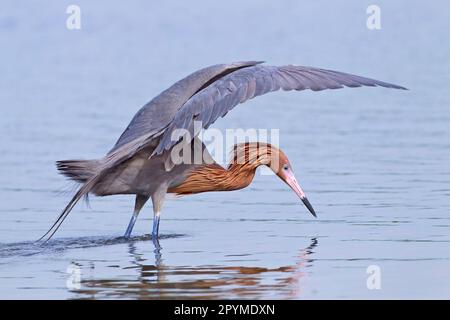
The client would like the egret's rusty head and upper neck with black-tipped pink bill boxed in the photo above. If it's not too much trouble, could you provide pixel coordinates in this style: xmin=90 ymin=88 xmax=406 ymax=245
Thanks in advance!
xmin=233 ymin=142 xmax=316 ymax=217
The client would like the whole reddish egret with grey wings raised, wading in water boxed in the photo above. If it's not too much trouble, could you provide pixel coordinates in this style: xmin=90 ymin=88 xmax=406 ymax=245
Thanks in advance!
xmin=41 ymin=61 xmax=405 ymax=239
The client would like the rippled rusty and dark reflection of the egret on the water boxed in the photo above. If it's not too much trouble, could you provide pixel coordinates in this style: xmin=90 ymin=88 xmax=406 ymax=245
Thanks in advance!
xmin=73 ymin=238 xmax=318 ymax=299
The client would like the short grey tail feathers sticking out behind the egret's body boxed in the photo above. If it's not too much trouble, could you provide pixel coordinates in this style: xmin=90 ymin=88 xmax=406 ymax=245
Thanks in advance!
xmin=56 ymin=160 xmax=100 ymax=183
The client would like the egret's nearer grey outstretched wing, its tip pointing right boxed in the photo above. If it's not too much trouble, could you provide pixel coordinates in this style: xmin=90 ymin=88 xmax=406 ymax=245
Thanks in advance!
xmin=153 ymin=65 xmax=406 ymax=154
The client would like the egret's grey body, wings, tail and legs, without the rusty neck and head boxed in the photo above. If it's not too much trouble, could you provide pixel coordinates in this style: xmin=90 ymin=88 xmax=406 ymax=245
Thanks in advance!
xmin=44 ymin=61 xmax=405 ymax=238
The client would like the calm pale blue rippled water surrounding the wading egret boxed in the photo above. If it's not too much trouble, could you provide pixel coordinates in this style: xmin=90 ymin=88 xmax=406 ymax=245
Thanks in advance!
xmin=0 ymin=1 xmax=450 ymax=299
